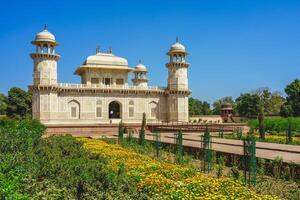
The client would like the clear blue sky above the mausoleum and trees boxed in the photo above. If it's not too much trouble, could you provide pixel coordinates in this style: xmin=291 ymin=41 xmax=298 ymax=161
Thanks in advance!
xmin=0 ymin=0 xmax=300 ymax=102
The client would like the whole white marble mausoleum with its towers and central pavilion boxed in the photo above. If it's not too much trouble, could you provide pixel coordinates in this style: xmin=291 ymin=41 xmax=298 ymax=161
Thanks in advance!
xmin=29 ymin=28 xmax=191 ymax=124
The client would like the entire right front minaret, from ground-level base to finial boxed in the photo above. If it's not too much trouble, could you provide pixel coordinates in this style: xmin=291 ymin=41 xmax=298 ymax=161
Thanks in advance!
xmin=166 ymin=38 xmax=191 ymax=122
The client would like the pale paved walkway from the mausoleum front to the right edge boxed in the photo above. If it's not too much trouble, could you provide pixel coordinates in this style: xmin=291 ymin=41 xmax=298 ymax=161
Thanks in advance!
xmin=46 ymin=126 xmax=300 ymax=164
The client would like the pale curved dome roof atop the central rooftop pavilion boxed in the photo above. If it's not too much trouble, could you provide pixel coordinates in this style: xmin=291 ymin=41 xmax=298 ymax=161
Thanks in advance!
xmin=84 ymin=52 xmax=128 ymax=67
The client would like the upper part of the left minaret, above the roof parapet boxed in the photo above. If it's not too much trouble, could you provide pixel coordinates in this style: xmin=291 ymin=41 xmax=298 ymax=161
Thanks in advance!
xmin=30 ymin=25 xmax=60 ymax=85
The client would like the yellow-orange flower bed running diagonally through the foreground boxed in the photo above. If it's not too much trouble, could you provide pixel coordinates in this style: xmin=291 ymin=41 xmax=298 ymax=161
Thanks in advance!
xmin=80 ymin=139 xmax=279 ymax=199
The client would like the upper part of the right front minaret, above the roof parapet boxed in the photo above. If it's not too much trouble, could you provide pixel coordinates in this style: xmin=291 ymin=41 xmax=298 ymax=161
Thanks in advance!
xmin=166 ymin=38 xmax=189 ymax=90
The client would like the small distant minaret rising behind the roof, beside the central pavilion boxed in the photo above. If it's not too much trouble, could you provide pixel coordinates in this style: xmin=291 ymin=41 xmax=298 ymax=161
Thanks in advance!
xmin=132 ymin=61 xmax=148 ymax=87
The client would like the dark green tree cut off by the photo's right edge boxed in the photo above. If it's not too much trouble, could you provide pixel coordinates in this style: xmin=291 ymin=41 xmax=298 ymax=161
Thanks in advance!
xmin=281 ymin=79 xmax=300 ymax=117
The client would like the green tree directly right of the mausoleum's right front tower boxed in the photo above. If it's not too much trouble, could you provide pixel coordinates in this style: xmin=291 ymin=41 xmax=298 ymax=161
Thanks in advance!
xmin=189 ymin=97 xmax=211 ymax=115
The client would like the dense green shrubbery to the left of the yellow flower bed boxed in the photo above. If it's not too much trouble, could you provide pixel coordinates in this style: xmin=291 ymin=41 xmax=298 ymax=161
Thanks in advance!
xmin=0 ymin=119 xmax=142 ymax=199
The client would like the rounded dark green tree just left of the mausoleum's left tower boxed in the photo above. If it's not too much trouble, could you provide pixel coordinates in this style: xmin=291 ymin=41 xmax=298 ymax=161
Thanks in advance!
xmin=7 ymin=87 xmax=32 ymax=118
